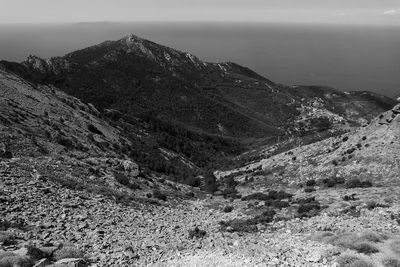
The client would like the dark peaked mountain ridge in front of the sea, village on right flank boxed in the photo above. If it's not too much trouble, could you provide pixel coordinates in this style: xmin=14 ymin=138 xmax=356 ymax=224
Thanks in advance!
xmin=1 ymin=35 xmax=395 ymax=138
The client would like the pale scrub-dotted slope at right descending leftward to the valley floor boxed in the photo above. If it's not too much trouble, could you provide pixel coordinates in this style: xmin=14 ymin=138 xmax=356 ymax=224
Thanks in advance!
xmin=218 ymin=105 xmax=400 ymax=186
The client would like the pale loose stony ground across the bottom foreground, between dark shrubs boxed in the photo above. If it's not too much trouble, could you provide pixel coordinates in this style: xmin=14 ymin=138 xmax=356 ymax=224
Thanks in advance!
xmin=0 ymin=158 xmax=400 ymax=266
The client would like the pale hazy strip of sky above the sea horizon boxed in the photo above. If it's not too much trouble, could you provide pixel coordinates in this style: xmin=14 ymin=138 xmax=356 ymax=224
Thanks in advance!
xmin=0 ymin=0 xmax=400 ymax=25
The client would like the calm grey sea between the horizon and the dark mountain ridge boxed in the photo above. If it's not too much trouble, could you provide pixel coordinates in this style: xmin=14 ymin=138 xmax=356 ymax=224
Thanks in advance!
xmin=0 ymin=23 xmax=400 ymax=97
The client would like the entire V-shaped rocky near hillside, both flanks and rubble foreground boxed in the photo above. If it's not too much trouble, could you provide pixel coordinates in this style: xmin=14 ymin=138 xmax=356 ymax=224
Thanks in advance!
xmin=0 ymin=68 xmax=400 ymax=266
